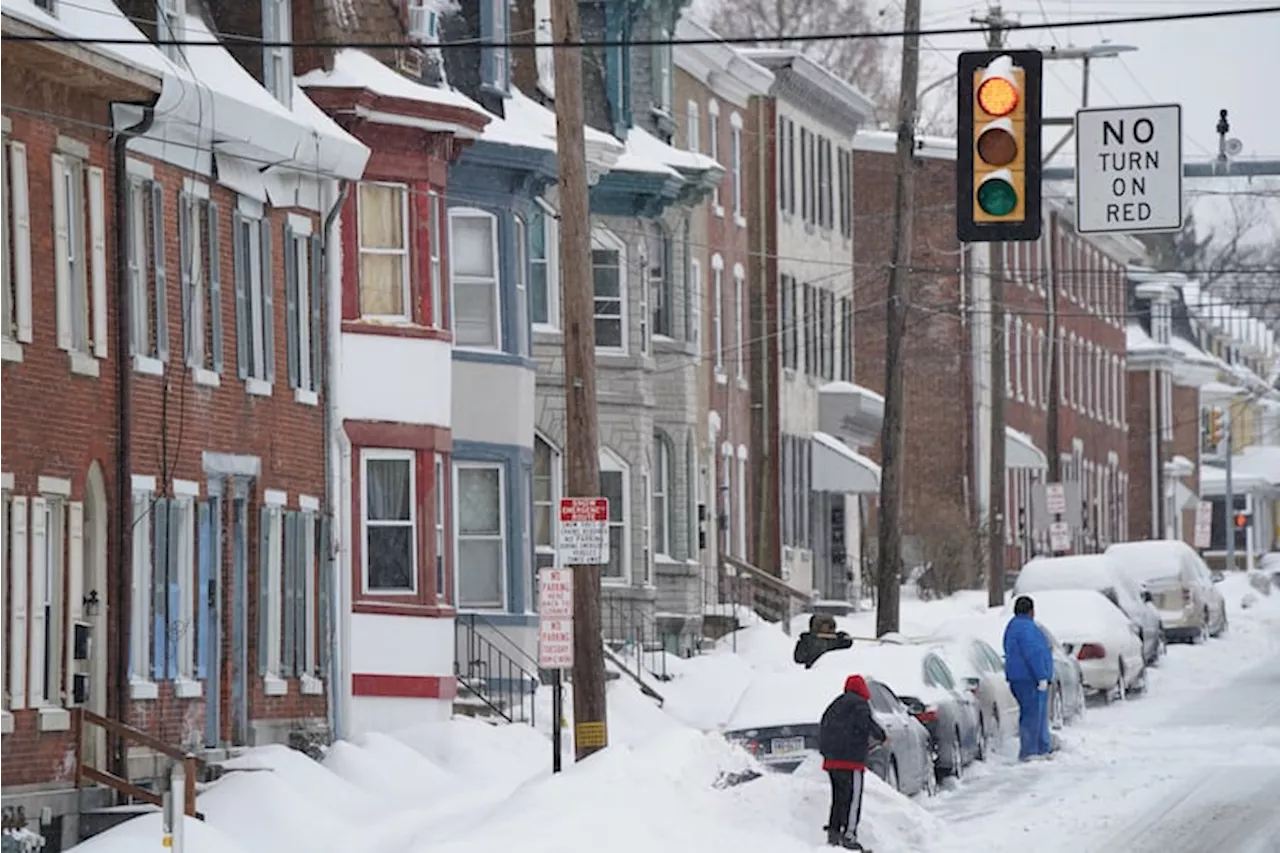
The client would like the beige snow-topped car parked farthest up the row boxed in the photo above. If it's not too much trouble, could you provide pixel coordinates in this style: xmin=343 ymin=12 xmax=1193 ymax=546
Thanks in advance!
xmin=1107 ymin=539 xmax=1226 ymax=643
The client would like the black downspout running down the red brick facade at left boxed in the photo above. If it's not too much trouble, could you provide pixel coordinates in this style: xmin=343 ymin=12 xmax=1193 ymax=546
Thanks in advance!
xmin=111 ymin=104 xmax=155 ymax=777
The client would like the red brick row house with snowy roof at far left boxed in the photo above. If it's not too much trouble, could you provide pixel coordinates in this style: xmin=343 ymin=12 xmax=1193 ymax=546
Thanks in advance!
xmin=0 ymin=0 xmax=369 ymax=844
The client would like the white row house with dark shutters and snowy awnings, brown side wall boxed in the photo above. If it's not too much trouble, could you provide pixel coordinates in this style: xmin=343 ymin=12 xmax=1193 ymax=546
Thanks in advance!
xmin=747 ymin=49 xmax=883 ymax=599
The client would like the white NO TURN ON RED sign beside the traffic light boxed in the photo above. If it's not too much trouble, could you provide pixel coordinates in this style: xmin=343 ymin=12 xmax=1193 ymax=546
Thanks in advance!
xmin=1075 ymin=104 xmax=1183 ymax=234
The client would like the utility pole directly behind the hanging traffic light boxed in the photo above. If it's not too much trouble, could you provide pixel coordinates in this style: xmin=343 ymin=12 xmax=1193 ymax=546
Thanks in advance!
xmin=970 ymin=5 xmax=1015 ymax=607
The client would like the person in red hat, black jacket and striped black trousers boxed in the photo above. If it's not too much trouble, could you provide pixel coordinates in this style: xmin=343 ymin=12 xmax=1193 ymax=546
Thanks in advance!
xmin=818 ymin=675 xmax=888 ymax=850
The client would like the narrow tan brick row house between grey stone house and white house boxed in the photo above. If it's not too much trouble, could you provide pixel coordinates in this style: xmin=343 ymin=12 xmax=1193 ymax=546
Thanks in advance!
xmin=673 ymin=15 xmax=773 ymax=627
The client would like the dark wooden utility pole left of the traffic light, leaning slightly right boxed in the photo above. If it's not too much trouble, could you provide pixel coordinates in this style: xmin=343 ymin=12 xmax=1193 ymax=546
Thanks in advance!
xmin=876 ymin=0 xmax=920 ymax=637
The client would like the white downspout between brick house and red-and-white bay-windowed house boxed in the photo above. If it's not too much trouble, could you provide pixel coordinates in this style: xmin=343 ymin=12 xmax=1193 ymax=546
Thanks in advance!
xmin=320 ymin=181 xmax=351 ymax=739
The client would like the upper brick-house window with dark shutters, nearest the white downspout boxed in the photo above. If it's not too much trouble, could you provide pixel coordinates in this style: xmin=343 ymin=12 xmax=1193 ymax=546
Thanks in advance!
xmin=284 ymin=214 xmax=324 ymax=401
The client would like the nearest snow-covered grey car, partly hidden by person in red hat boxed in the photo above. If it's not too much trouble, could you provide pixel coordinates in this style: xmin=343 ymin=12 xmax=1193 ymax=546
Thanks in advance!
xmin=724 ymin=670 xmax=937 ymax=795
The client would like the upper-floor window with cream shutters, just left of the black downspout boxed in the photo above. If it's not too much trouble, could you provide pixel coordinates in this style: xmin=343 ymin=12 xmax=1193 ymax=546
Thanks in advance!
xmin=51 ymin=151 xmax=108 ymax=363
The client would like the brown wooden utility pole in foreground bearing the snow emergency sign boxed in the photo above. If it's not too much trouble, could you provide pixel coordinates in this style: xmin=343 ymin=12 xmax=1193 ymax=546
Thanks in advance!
xmin=552 ymin=0 xmax=609 ymax=761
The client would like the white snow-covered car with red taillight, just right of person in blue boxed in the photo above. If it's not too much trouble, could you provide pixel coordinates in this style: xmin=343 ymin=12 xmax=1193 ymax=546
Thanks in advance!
xmin=1005 ymin=589 xmax=1147 ymax=701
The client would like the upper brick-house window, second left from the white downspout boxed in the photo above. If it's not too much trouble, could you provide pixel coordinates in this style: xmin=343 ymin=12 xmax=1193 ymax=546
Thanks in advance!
xmin=232 ymin=202 xmax=275 ymax=388
